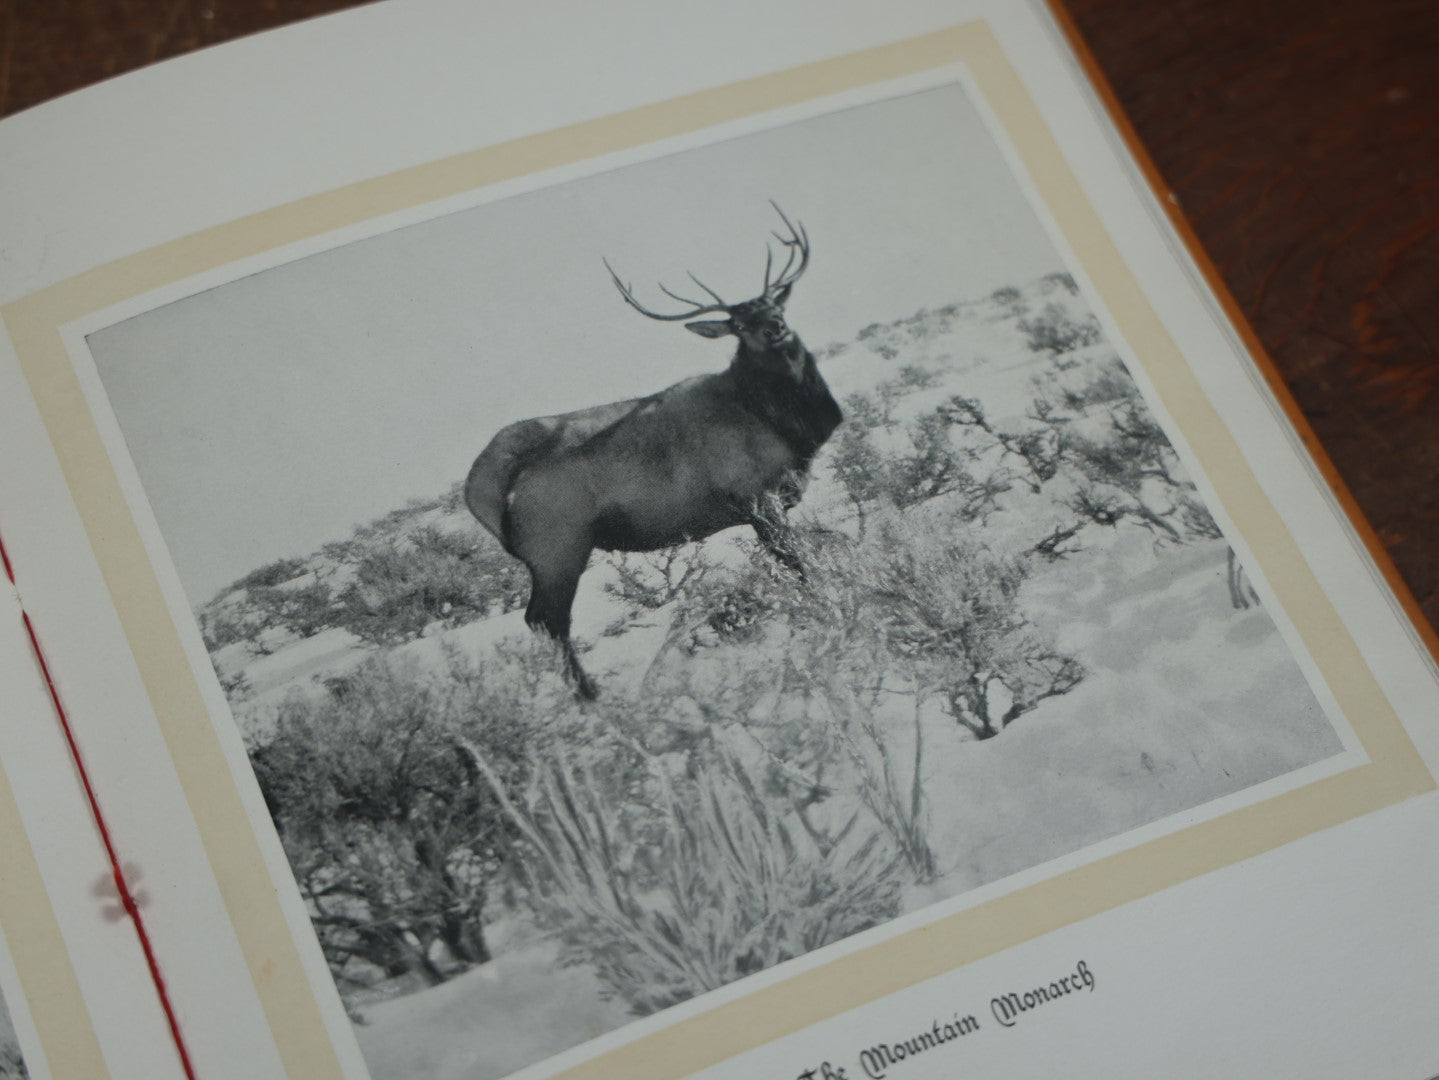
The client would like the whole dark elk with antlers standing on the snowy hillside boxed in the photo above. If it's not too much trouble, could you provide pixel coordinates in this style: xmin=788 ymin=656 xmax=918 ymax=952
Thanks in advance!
xmin=465 ymin=207 xmax=842 ymax=697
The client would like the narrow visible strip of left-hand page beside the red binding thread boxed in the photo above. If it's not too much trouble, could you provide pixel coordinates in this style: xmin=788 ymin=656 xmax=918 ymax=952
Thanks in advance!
xmin=0 ymin=552 xmax=191 ymax=1077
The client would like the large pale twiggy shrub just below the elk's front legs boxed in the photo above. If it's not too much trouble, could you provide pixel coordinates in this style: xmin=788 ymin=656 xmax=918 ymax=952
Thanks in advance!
xmin=673 ymin=508 xmax=1084 ymax=882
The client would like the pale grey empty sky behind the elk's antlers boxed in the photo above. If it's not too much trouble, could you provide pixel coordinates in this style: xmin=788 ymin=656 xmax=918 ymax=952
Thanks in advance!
xmin=89 ymin=86 xmax=1061 ymax=604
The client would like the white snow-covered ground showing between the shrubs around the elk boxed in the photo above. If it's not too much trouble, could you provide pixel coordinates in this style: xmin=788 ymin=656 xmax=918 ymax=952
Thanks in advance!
xmin=200 ymin=276 xmax=1341 ymax=1080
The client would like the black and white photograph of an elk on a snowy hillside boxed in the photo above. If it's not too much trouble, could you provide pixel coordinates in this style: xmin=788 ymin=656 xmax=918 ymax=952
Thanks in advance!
xmin=84 ymin=83 xmax=1344 ymax=1080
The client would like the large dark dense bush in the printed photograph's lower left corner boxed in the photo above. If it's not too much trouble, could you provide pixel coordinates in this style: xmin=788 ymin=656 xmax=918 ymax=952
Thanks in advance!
xmin=250 ymin=650 xmax=563 ymax=987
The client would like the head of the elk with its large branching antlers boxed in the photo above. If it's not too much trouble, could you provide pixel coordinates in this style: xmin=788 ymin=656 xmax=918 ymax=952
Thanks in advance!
xmin=604 ymin=200 xmax=810 ymax=381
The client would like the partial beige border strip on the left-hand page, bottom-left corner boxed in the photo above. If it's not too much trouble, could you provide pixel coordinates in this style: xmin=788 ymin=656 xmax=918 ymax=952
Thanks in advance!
xmin=0 ymin=764 xmax=109 ymax=1080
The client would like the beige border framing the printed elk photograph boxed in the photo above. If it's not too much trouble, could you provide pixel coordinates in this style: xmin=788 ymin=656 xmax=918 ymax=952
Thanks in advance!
xmin=0 ymin=22 xmax=1435 ymax=1080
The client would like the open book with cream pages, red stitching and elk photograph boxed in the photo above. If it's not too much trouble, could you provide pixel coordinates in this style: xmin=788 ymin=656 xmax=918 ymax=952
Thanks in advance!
xmin=0 ymin=0 xmax=1439 ymax=1080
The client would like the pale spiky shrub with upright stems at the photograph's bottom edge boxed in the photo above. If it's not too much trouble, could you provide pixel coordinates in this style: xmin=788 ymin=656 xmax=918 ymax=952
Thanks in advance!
xmin=476 ymin=752 xmax=899 ymax=1015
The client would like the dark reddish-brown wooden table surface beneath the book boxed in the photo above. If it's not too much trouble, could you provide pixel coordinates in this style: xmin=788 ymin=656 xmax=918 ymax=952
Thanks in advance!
xmin=0 ymin=0 xmax=1439 ymax=638
